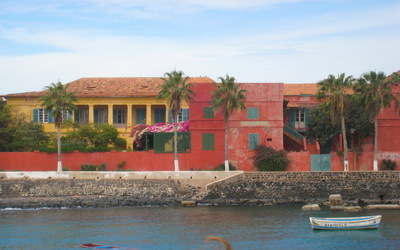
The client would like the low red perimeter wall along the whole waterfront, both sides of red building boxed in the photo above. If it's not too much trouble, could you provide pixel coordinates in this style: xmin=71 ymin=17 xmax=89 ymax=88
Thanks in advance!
xmin=0 ymin=150 xmax=400 ymax=171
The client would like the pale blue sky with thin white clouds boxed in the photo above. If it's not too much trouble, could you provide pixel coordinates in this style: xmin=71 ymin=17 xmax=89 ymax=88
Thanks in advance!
xmin=0 ymin=0 xmax=400 ymax=94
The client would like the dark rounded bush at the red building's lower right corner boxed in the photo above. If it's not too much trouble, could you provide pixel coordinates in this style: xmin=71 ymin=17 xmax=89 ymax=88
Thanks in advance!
xmin=252 ymin=145 xmax=289 ymax=171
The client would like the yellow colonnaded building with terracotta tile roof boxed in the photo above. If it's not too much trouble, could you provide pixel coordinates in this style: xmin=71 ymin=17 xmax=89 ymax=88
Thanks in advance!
xmin=3 ymin=77 xmax=214 ymax=148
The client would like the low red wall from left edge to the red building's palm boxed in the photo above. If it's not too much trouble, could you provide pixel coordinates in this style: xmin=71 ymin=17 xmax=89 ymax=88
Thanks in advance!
xmin=0 ymin=151 xmax=222 ymax=171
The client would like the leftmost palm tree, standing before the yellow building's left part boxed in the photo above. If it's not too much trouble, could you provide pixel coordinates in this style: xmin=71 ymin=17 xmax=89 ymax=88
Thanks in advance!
xmin=39 ymin=82 xmax=77 ymax=172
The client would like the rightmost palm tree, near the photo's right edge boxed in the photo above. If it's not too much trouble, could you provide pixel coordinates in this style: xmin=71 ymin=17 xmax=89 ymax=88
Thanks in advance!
xmin=354 ymin=71 xmax=394 ymax=171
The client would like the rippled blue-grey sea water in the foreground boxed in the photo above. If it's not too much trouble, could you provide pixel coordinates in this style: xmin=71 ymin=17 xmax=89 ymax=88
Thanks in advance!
xmin=0 ymin=206 xmax=400 ymax=249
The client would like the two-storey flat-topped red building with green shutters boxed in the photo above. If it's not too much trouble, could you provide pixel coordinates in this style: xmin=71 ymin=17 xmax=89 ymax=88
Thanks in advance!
xmin=189 ymin=83 xmax=283 ymax=171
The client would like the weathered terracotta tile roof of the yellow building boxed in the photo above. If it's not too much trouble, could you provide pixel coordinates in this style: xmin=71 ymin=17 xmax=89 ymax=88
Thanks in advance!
xmin=4 ymin=77 xmax=214 ymax=98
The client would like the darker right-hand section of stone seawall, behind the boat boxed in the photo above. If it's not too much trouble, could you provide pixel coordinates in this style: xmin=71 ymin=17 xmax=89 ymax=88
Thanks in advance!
xmin=203 ymin=171 xmax=400 ymax=205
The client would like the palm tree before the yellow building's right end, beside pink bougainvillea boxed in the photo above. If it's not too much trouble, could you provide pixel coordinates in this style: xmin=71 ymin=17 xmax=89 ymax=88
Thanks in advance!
xmin=157 ymin=70 xmax=194 ymax=171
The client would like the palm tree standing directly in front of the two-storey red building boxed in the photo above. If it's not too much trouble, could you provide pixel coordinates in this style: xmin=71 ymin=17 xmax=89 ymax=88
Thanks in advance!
xmin=211 ymin=75 xmax=247 ymax=171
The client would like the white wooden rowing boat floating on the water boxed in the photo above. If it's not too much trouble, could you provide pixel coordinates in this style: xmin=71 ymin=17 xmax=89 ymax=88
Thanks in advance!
xmin=310 ymin=215 xmax=382 ymax=230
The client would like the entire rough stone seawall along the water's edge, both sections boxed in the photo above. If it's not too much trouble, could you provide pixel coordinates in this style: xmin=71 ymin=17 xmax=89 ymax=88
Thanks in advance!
xmin=0 ymin=171 xmax=400 ymax=209
